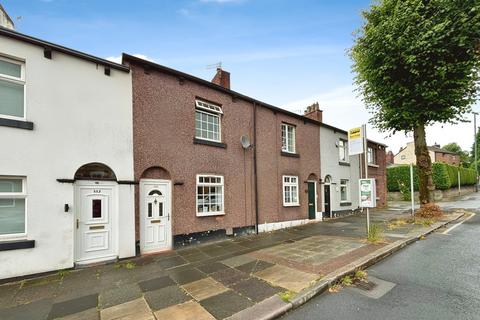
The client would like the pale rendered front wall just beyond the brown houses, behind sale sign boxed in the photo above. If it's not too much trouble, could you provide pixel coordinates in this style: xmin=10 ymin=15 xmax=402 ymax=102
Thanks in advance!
xmin=320 ymin=127 xmax=360 ymax=212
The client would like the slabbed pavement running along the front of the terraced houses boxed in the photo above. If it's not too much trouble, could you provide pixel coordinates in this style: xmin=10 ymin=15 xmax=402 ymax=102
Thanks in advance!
xmin=0 ymin=195 xmax=472 ymax=320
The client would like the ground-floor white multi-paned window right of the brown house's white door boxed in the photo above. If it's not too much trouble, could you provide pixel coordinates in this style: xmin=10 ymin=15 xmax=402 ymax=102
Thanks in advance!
xmin=197 ymin=174 xmax=225 ymax=217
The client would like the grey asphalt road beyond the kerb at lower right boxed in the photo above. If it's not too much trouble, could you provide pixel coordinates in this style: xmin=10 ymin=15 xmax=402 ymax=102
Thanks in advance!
xmin=282 ymin=195 xmax=480 ymax=320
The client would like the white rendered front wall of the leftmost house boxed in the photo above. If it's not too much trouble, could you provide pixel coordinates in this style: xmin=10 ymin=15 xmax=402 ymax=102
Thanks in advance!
xmin=0 ymin=36 xmax=135 ymax=278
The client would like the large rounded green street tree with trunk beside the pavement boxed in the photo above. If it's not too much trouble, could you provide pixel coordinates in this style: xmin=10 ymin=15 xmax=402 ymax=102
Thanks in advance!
xmin=350 ymin=0 xmax=480 ymax=204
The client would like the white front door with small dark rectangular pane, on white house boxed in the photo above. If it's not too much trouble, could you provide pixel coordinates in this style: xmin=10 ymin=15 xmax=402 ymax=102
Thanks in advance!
xmin=74 ymin=181 xmax=118 ymax=264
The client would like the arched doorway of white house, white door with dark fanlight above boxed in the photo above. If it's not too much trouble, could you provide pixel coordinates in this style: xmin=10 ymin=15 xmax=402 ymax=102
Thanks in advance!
xmin=74 ymin=162 xmax=118 ymax=264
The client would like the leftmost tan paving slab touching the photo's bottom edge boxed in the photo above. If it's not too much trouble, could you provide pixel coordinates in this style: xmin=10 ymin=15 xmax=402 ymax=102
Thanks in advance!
xmin=100 ymin=298 xmax=155 ymax=320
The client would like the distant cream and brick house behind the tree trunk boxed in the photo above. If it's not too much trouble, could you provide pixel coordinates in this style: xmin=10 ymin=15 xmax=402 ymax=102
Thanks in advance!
xmin=394 ymin=141 xmax=460 ymax=166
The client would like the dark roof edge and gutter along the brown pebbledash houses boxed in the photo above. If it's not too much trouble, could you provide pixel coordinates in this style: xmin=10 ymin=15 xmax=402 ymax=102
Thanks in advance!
xmin=122 ymin=53 xmax=321 ymax=125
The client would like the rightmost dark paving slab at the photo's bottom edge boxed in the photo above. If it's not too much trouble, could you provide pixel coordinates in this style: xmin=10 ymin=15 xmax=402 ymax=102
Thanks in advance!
xmin=200 ymin=290 xmax=253 ymax=319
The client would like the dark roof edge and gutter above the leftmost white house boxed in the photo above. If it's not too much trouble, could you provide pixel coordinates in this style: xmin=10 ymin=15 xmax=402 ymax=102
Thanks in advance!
xmin=0 ymin=27 xmax=130 ymax=72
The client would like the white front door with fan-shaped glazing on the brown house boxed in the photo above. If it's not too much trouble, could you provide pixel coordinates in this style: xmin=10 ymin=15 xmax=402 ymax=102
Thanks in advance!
xmin=140 ymin=179 xmax=172 ymax=253
